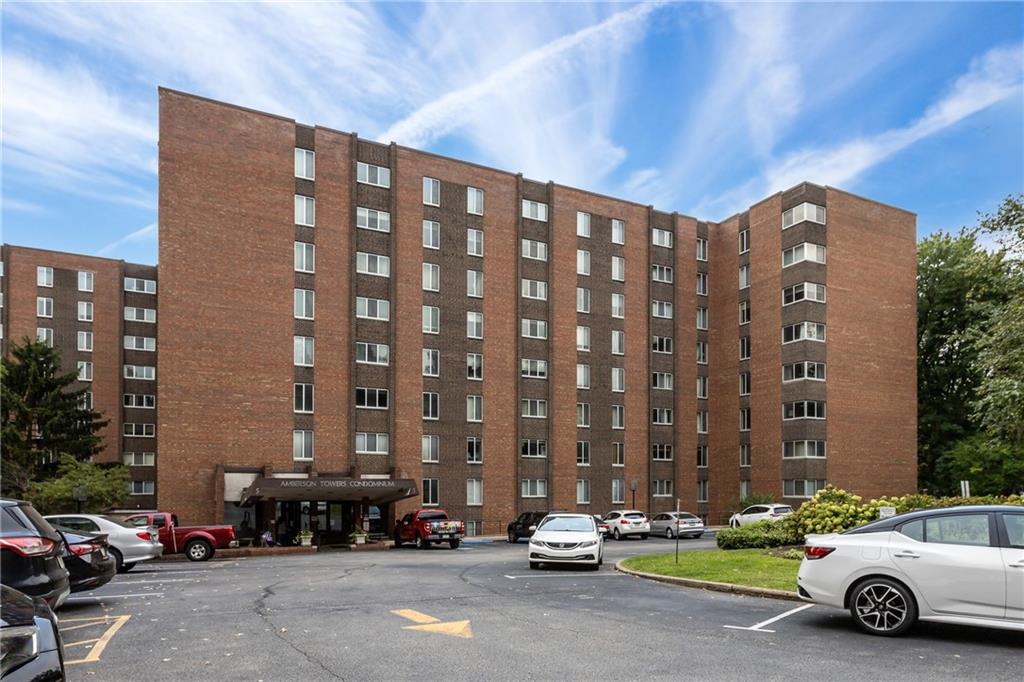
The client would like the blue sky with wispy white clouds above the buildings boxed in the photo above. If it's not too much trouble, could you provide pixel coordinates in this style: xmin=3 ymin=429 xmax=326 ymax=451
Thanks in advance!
xmin=2 ymin=2 xmax=1024 ymax=263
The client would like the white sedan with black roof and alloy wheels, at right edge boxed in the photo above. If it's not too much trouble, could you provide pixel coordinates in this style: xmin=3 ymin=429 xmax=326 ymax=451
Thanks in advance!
xmin=797 ymin=505 xmax=1024 ymax=636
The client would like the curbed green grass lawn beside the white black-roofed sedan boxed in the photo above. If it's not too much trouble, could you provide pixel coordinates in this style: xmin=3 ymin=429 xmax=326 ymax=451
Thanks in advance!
xmin=623 ymin=549 xmax=800 ymax=592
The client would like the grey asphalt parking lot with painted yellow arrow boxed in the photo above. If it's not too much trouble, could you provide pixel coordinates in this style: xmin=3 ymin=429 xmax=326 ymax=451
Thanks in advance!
xmin=59 ymin=538 xmax=1024 ymax=681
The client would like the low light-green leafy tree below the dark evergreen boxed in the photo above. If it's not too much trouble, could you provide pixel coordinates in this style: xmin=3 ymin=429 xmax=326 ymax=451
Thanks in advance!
xmin=26 ymin=455 xmax=131 ymax=514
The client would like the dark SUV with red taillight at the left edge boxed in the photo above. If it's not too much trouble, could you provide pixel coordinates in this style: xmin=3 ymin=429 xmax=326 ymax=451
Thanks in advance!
xmin=0 ymin=493 xmax=71 ymax=608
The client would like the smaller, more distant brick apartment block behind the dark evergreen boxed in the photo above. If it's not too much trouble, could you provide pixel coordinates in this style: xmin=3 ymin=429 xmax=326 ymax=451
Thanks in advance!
xmin=0 ymin=245 xmax=157 ymax=501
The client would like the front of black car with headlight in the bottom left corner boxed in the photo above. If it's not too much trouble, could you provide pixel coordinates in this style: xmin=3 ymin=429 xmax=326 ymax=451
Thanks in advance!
xmin=0 ymin=585 xmax=65 ymax=682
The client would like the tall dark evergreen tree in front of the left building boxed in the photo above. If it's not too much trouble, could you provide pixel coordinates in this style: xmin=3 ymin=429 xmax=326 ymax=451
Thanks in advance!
xmin=0 ymin=339 xmax=106 ymax=497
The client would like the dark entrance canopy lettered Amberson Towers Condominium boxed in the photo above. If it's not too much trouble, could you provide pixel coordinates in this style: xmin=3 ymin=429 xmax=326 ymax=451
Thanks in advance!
xmin=240 ymin=476 xmax=420 ymax=507
